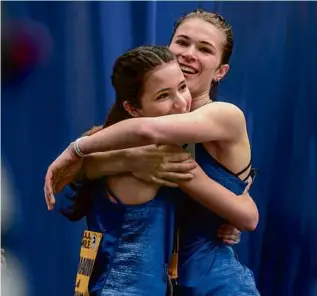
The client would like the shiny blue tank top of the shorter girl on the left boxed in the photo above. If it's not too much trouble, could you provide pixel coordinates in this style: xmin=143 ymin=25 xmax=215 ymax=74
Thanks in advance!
xmin=57 ymin=180 xmax=179 ymax=296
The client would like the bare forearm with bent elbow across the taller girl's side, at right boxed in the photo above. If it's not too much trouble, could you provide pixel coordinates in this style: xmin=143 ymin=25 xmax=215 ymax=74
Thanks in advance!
xmin=179 ymin=167 xmax=259 ymax=231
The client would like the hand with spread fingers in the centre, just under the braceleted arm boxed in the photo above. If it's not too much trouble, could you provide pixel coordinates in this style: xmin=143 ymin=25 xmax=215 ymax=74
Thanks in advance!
xmin=132 ymin=145 xmax=197 ymax=187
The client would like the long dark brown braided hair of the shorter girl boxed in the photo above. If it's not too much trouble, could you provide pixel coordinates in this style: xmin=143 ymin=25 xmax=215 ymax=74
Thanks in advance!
xmin=62 ymin=46 xmax=176 ymax=221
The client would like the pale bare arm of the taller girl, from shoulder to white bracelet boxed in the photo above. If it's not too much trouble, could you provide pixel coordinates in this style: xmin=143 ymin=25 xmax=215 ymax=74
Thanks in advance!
xmin=80 ymin=103 xmax=245 ymax=154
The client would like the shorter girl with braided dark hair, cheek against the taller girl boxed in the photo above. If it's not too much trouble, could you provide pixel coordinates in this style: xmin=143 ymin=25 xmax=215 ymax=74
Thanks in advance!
xmin=59 ymin=46 xmax=200 ymax=296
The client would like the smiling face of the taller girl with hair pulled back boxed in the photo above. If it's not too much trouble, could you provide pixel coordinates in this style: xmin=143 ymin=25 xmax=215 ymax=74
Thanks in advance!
xmin=169 ymin=17 xmax=229 ymax=97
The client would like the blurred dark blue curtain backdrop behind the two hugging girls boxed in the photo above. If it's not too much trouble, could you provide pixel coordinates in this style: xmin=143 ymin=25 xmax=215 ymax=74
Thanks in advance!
xmin=1 ymin=1 xmax=317 ymax=296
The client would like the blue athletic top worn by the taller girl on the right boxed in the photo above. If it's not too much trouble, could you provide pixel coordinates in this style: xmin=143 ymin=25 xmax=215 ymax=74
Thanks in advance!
xmin=177 ymin=144 xmax=259 ymax=296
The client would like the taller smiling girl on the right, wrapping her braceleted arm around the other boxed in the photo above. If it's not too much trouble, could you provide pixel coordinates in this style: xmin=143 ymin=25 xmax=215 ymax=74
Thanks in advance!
xmin=48 ymin=10 xmax=259 ymax=296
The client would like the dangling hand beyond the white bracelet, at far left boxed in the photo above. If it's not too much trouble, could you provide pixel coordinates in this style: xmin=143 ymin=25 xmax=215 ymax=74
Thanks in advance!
xmin=44 ymin=144 xmax=83 ymax=210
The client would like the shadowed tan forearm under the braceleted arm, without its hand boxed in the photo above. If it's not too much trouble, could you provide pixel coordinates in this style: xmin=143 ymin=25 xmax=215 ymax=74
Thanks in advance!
xmin=83 ymin=148 xmax=133 ymax=180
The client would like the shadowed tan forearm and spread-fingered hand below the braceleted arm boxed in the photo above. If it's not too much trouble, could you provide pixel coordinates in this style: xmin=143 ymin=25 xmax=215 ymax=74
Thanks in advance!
xmin=82 ymin=145 xmax=196 ymax=187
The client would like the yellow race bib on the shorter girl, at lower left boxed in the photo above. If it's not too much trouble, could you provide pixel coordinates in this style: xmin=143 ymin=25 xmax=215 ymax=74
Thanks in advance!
xmin=75 ymin=230 xmax=102 ymax=296
